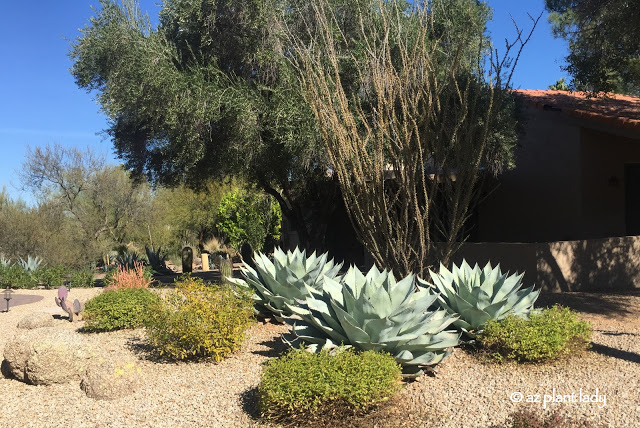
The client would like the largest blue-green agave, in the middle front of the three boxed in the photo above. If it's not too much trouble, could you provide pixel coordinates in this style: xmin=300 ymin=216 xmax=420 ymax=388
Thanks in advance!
xmin=287 ymin=266 xmax=460 ymax=375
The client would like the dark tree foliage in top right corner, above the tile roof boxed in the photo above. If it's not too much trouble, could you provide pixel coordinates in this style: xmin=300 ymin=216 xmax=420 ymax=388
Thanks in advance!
xmin=545 ymin=0 xmax=640 ymax=96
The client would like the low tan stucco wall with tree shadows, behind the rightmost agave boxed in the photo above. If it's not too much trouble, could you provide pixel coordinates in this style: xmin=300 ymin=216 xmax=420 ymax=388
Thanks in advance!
xmin=454 ymin=236 xmax=640 ymax=291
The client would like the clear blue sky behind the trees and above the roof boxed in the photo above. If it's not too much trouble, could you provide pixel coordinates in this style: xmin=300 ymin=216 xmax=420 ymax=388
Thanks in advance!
xmin=0 ymin=0 xmax=567 ymax=202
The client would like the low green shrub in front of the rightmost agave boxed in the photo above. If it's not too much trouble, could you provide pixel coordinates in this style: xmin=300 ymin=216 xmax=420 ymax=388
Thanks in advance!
xmin=478 ymin=305 xmax=591 ymax=362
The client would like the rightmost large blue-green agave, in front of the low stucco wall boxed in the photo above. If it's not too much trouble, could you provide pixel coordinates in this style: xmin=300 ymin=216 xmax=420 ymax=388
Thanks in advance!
xmin=419 ymin=260 xmax=540 ymax=337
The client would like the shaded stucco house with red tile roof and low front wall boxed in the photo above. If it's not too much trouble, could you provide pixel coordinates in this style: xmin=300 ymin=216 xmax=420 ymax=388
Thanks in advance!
xmin=456 ymin=90 xmax=640 ymax=291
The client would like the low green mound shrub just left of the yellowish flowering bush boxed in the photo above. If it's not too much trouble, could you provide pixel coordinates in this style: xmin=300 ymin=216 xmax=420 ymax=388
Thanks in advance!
xmin=83 ymin=288 xmax=159 ymax=332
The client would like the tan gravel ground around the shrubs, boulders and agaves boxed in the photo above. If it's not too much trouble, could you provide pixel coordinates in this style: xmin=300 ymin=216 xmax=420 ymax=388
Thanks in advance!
xmin=0 ymin=289 xmax=640 ymax=428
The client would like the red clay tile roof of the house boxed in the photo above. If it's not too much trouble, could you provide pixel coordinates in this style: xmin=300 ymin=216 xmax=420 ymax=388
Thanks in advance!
xmin=514 ymin=89 xmax=640 ymax=131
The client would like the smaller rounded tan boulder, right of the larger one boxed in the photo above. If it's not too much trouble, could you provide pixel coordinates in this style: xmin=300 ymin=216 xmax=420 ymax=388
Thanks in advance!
xmin=80 ymin=359 xmax=142 ymax=400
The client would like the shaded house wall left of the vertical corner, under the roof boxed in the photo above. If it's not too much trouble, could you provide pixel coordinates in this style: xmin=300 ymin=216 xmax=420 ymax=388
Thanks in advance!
xmin=475 ymin=108 xmax=581 ymax=242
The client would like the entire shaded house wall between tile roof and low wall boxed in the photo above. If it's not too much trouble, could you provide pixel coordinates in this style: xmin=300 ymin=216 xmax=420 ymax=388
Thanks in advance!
xmin=474 ymin=107 xmax=640 ymax=242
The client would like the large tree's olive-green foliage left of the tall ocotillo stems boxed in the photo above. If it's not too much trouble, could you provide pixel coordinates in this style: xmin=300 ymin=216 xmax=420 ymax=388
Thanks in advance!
xmin=70 ymin=0 xmax=338 ymax=249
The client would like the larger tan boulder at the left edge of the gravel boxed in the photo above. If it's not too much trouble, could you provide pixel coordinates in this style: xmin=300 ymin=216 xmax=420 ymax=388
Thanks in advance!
xmin=3 ymin=327 xmax=92 ymax=385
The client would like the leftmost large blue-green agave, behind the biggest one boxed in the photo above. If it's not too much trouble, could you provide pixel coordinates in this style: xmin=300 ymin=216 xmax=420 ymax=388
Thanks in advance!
xmin=229 ymin=247 xmax=342 ymax=322
